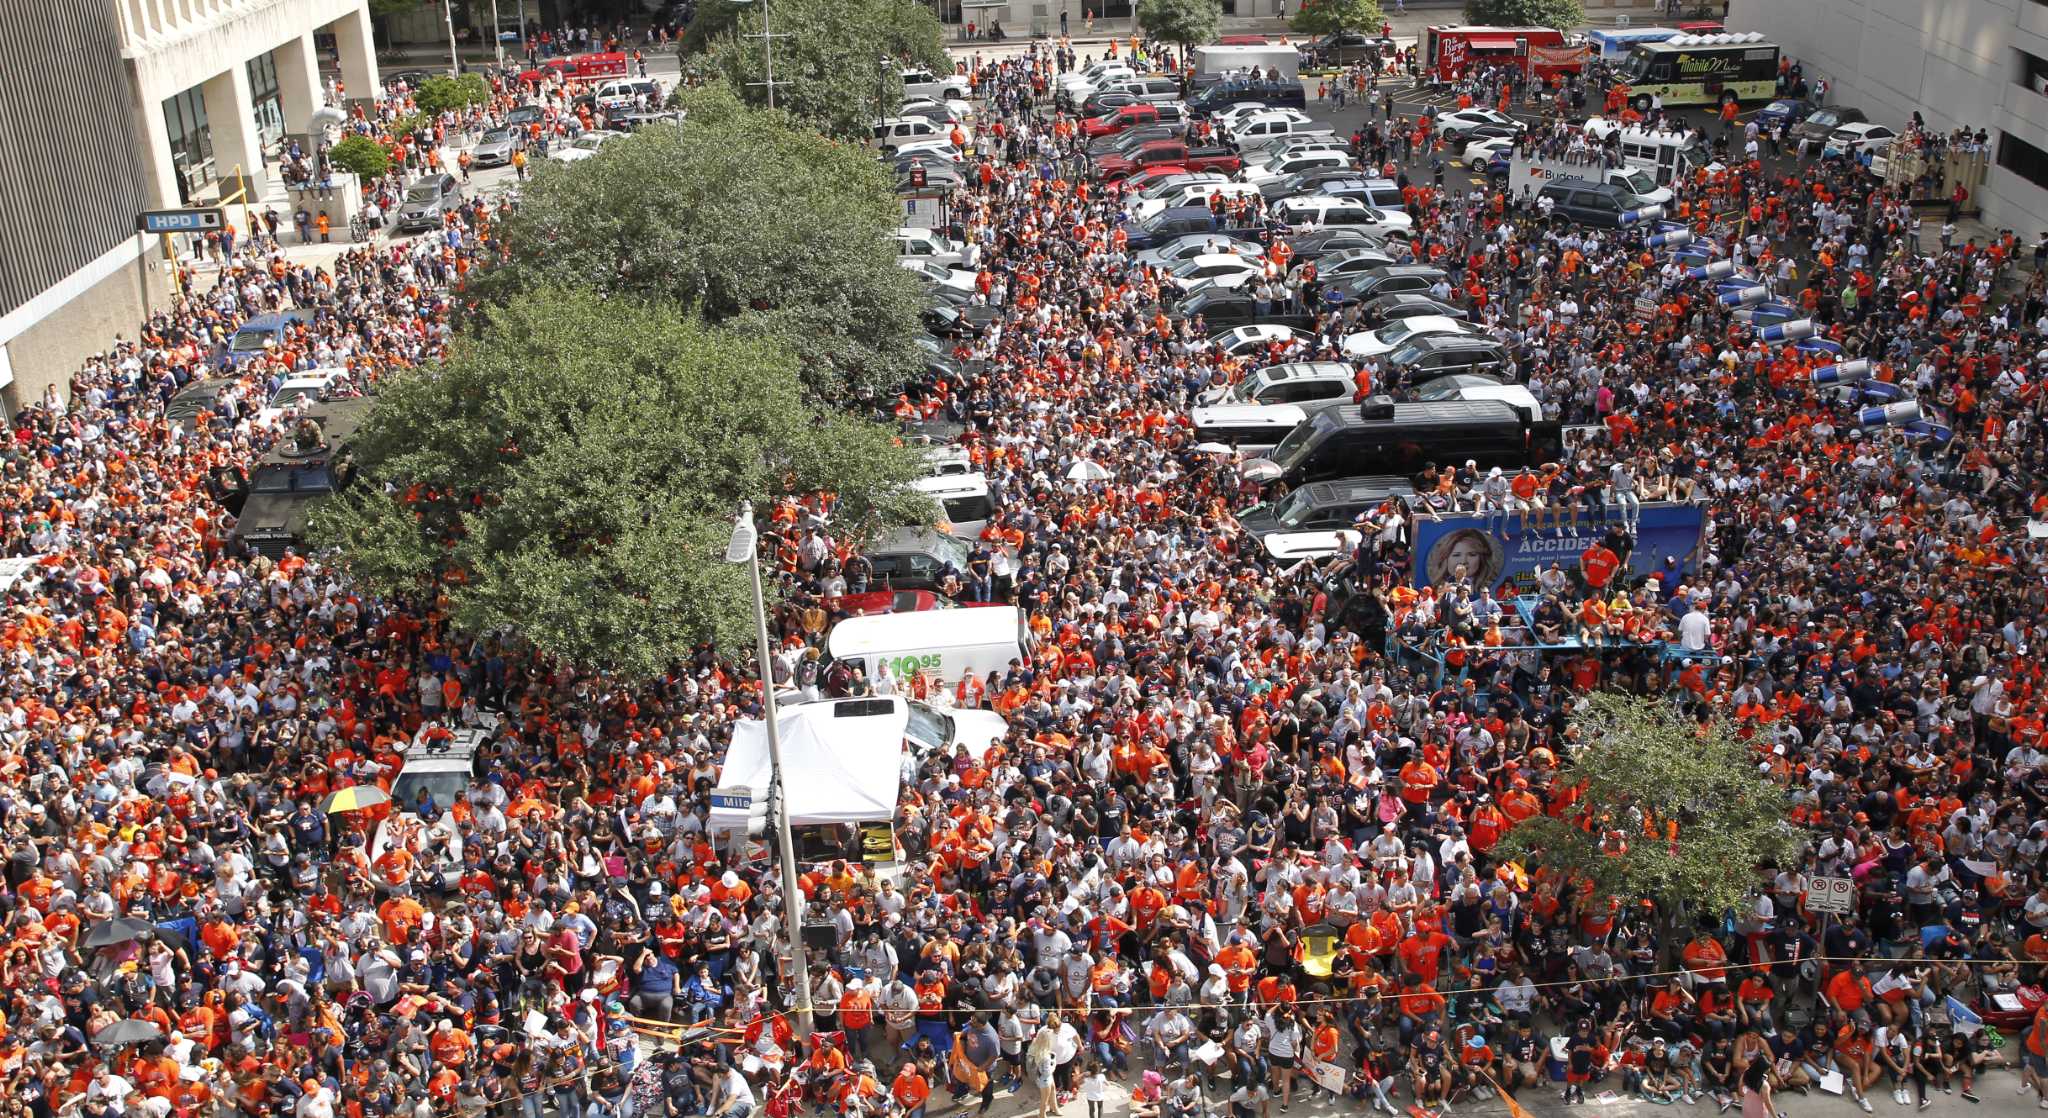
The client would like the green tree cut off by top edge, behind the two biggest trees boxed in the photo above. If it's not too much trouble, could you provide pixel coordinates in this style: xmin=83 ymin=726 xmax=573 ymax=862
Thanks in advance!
xmin=680 ymin=0 xmax=952 ymax=141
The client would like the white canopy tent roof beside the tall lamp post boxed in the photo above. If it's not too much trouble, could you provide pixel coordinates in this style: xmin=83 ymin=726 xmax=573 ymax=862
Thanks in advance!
xmin=719 ymin=698 xmax=909 ymax=825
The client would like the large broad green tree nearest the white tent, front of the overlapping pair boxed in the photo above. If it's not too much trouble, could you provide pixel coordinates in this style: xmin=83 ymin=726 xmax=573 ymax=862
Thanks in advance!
xmin=311 ymin=289 xmax=934 ymax=678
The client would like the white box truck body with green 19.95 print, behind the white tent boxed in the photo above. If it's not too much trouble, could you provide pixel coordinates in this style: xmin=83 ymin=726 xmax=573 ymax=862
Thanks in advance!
xmin=825 ymin=606 xmax=1034 ymax=690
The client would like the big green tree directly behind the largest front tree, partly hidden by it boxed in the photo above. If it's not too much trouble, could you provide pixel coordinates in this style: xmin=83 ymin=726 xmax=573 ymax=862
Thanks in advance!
xmin=475 ymin=86 xmax=924 ymax=397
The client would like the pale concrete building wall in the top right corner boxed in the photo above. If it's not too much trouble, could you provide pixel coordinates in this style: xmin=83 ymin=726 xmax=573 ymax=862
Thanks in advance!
xmin=1729 ymin=0 xmax=2048 ymax=238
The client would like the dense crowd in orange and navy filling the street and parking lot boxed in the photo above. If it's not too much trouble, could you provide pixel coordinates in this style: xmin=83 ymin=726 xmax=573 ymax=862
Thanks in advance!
xmin=12 ymin=23 xmax=2048 ymax=1118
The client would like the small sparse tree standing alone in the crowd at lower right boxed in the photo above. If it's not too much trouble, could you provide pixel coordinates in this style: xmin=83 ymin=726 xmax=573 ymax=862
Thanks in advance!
xmin=1495 ymin=692 xmax=1796 ymax=919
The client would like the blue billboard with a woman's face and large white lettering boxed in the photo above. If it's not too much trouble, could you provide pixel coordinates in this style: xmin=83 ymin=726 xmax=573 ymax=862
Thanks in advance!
xmin=1409 ymin=504 xmax=1706 ymax=594
